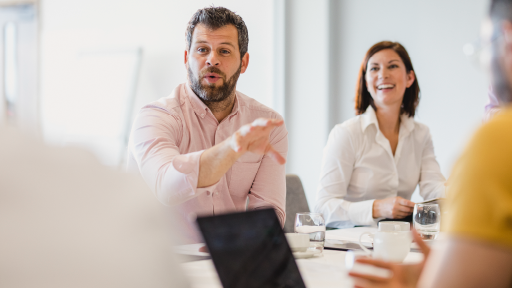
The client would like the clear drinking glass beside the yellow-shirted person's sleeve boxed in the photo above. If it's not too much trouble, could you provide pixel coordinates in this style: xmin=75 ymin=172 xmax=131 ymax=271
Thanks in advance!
xmin=413 ymin=204 xmax=441 ymax=240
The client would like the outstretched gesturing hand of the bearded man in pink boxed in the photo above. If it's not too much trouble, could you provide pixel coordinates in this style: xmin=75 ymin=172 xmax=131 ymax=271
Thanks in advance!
xmin=229 ymin=118 xmax=286 ymax=164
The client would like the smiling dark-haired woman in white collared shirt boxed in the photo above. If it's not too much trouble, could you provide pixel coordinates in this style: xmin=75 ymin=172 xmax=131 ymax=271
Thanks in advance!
xmin=315 ymin=41 xmax=445 ymax=228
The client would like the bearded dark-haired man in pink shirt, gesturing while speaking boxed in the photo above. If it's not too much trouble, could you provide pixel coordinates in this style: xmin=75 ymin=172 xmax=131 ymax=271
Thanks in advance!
xmin=129 ymin=7 xmax=288 ymax=243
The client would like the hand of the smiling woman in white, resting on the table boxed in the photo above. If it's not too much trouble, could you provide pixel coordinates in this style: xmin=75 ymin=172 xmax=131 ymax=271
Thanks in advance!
xmin=373 ymin=196 xmax=414 ymax=219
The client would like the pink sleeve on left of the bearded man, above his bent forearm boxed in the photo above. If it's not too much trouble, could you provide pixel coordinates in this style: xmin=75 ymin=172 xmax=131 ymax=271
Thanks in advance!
xmin=128 ymin=105 xmax=217 ymax=205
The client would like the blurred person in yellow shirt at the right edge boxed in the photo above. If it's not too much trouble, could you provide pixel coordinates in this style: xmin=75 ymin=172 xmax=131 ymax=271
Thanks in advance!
xmin=351 ymin=0 xmax=512 ymax=288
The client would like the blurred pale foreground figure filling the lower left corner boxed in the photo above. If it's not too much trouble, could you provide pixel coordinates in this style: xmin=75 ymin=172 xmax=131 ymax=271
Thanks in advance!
xmin=0 ymin=123 xmax=188 ymax=288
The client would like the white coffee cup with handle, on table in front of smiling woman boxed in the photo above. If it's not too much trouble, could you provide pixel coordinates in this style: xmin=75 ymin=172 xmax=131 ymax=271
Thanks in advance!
xmin=359 ymin=231 xmax=412 ymax=262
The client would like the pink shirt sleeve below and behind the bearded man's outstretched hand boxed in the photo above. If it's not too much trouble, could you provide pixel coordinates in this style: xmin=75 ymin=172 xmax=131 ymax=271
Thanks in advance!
xmin=248 ymin=116 xmax=288 ymax=226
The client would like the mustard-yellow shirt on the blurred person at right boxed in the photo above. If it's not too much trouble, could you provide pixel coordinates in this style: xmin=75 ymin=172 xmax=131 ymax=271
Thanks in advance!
xmin=442 ymin=107 xmax=512 ymax=248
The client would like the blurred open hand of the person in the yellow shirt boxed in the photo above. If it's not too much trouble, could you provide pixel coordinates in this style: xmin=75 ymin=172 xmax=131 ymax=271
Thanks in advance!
xmin=348 ymin=229 xmax=430 ymax=288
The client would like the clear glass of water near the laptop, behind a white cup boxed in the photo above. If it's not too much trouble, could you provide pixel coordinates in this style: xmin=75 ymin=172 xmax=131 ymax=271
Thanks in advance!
xmin=295 ymin=212 xmax=325 ymax=252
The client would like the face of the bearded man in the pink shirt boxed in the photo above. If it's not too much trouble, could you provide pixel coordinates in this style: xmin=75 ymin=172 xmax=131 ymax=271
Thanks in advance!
xmin=185 ymin=24 xmax=249 ymax=102
